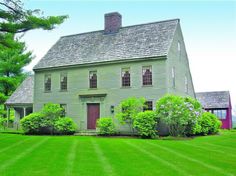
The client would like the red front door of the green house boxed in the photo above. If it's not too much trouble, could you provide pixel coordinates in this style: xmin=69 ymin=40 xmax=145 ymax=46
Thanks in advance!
xmin=87 ymin=104 xmax=100 ymax=129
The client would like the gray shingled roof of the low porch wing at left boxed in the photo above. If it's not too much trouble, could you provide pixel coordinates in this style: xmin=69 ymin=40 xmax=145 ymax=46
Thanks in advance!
xmin=5 ymin=76 xmax=34 ymax=105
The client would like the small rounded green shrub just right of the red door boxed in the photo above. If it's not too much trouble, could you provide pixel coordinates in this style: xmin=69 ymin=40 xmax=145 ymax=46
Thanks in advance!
xmin=97 ymin=117 xmax=115 ymax=136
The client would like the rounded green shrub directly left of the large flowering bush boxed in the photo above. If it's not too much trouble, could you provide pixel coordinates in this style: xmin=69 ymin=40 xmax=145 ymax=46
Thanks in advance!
xmin=134 ymin=111 xmax=157 ymax=138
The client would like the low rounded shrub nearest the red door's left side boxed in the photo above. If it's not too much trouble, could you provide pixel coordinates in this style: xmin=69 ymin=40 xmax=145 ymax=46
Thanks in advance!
xmin=54 ymin=117 xmax=76 ymax=134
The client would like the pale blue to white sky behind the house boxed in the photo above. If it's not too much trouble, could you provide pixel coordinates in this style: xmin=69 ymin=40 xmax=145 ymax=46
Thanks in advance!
xmin=22 ymin=0 xmax=236 ymax=115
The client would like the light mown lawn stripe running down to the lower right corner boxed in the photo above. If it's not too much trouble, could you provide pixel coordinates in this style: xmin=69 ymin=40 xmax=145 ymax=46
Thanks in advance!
xmin=145 ymin=142 xmax=234 ymax=176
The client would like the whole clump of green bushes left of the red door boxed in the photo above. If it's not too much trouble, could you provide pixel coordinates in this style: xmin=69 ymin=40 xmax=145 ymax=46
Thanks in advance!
xmin=20 ymin=103 xmax=77 ymax=134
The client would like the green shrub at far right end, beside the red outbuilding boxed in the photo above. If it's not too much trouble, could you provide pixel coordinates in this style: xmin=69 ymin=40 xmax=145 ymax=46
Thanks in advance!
xmin=195 ymin=112 xmax=221 ymax=135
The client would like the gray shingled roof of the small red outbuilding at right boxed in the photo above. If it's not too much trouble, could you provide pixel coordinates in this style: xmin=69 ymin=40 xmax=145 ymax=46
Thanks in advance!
xmin=196 ymin=91 xmax=230 ymax=109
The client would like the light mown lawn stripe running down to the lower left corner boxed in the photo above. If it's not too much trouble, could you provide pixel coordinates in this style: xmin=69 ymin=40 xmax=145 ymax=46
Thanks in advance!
xmin=0 ymin=137 xmax=48 ymax=173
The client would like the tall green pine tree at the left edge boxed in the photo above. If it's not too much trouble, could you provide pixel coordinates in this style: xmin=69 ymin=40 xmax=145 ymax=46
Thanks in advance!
xmin=0 ymin=0 xmax=67 ymax=116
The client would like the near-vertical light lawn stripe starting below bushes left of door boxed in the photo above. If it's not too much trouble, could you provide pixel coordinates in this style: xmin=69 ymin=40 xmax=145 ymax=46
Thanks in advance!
xmin=65 ymin=138 xmax=79 ymax=176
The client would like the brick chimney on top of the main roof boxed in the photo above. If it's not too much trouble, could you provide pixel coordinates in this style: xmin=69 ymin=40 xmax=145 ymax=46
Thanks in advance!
xmin=104 ymin=12 xmax=122 ymax=34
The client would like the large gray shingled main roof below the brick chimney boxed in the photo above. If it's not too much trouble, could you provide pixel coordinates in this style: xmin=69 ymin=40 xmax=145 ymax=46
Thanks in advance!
xmin=34 ymin=19 xmax=179 ymax=69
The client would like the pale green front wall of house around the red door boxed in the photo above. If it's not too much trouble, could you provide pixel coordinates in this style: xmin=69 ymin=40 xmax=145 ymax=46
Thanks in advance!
xmin=34 ymin=59 xmax=167 ymax=130
